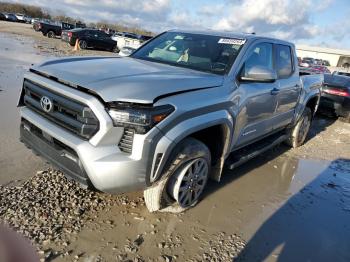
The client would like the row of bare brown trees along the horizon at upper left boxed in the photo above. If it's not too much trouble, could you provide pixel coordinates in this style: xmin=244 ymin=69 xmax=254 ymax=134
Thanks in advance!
xmin=0 ymin=2 xmax=154 ymax=35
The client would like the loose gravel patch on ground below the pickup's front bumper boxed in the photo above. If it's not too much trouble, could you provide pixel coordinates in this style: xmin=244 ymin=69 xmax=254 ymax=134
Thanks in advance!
xmin=0 ymin=169 xmax=124 ymax=248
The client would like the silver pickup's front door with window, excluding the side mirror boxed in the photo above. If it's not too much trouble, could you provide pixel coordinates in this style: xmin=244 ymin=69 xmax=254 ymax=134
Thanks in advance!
xmin=235 ymin=42 xmax=277 ymax=147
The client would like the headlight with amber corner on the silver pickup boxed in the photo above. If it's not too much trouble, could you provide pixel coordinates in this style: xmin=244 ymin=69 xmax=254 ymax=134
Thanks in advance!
xmin=108 ymin=103 xmax=175 ymax=134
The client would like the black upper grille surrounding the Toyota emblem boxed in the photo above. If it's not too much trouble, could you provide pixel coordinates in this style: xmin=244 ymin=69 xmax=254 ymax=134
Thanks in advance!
xmin=23 ymin=80 xmax=99 ymax=139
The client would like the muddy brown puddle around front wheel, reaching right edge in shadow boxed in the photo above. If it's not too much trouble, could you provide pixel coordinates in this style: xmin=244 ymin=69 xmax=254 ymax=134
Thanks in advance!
xmin=72 ymin=155 xmax=350 ymax=261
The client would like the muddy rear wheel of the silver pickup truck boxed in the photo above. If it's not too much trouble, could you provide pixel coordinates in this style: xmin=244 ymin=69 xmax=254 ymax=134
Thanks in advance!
xmin=286 ymin=107 xmax=312 ymax=148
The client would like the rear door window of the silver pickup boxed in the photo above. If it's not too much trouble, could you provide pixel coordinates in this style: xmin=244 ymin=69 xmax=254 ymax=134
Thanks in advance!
xmin=276 ymin=45 xmax=293 ymax=78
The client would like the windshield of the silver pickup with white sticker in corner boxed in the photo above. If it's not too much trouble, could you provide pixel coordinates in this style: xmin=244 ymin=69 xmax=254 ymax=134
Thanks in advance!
xmin=131 ymin=32 xmax=245 ymax=75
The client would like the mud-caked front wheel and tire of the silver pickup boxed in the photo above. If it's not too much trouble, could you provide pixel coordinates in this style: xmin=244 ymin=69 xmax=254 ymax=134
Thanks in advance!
xmin=144 ymin=138 xmax=211 ymax=213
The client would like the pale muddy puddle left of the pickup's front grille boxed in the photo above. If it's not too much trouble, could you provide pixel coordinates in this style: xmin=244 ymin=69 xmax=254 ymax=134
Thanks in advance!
xmin=0 ymin=33 xmax=47 ymax=184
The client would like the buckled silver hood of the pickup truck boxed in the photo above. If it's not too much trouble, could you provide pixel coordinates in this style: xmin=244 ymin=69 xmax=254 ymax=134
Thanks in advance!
xmin=32 ymin=57 xmax=223 ymax=104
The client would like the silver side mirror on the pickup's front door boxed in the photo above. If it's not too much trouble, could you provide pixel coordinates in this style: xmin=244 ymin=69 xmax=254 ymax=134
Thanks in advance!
xmin=240 ymin=66 xmax=277 ymax=83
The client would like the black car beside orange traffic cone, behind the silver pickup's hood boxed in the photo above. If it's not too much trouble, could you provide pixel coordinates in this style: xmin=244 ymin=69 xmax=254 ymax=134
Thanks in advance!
xmin=61 ymin=28 xmax=117 ymax=51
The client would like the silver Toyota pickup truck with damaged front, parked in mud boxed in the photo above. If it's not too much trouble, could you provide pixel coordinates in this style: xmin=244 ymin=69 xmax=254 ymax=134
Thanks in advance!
xmin=19 ymin=31 xmax=323 ymax=211
